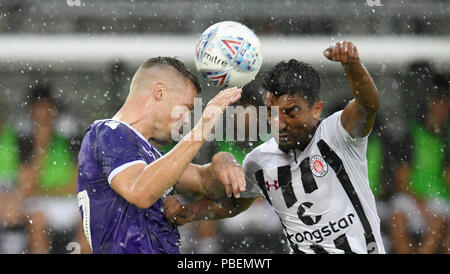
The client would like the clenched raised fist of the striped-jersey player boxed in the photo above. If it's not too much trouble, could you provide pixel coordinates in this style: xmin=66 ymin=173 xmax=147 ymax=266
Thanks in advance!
xmin=323 ymin=41 xmax=359 ymax=65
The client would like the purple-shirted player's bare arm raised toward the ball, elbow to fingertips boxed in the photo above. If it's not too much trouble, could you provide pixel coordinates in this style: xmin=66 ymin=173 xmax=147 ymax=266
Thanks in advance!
xmin=111 ymin=88 xmax=242 ymax=209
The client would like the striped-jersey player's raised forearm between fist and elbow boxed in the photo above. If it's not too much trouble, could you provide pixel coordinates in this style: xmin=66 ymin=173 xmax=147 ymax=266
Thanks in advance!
xmin=344 ymin=61 xmax=379 ymax=113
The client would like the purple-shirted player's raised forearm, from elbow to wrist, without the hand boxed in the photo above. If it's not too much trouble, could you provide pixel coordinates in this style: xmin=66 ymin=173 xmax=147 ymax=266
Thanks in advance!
xmin=131 ymin=124 xmax=205 ymax=208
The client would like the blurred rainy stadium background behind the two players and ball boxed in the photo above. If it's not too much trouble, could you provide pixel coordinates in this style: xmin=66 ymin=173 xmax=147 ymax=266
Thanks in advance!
xmin=0 ymin=0 xmax=450 ymax=253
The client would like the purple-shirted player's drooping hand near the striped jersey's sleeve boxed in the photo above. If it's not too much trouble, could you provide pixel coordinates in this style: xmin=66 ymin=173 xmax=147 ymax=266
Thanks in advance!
xmin=211 ymin=152 xmax=245 ymax=198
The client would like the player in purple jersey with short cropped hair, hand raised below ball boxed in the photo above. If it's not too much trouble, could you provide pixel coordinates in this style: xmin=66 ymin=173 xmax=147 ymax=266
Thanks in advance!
xmin=78 ymin=57 xmax=245 ymax=254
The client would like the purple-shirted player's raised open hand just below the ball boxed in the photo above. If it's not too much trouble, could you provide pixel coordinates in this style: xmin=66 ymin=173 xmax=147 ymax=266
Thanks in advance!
xmin=201 ymin=87 xmax=242 ymax=138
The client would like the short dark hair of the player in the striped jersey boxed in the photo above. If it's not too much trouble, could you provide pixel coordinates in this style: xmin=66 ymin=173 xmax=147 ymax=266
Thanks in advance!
xmin=263 ymin=59 xmax=320 ymax=105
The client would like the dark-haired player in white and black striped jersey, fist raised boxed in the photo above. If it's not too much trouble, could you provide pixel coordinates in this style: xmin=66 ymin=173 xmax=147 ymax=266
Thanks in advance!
xmin=165 ymin=41 xmax=385 ymax=253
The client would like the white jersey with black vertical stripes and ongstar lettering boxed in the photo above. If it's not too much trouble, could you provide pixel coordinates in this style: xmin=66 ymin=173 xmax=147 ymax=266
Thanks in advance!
xmin=241 ymin=111 xmax=385 ymax=253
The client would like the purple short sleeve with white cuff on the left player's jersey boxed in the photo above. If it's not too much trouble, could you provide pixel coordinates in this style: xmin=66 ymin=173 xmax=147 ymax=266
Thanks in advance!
xmin=94 ymin=121 xmax=147 ymax=184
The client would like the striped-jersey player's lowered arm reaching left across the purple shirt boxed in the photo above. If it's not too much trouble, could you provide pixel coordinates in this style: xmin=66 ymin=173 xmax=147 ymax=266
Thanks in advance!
xmin=163 ymin=196 xmax=256 ymax=225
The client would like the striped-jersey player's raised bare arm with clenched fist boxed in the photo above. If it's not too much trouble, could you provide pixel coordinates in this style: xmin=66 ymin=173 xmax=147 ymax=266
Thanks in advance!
xmin=324 ymin=41 xmax=379 ymax=138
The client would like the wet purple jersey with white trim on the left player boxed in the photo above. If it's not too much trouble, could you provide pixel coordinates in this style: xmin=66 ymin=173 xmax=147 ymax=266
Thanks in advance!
xmin=78 ymin=120 xmax=180 ymax=254
